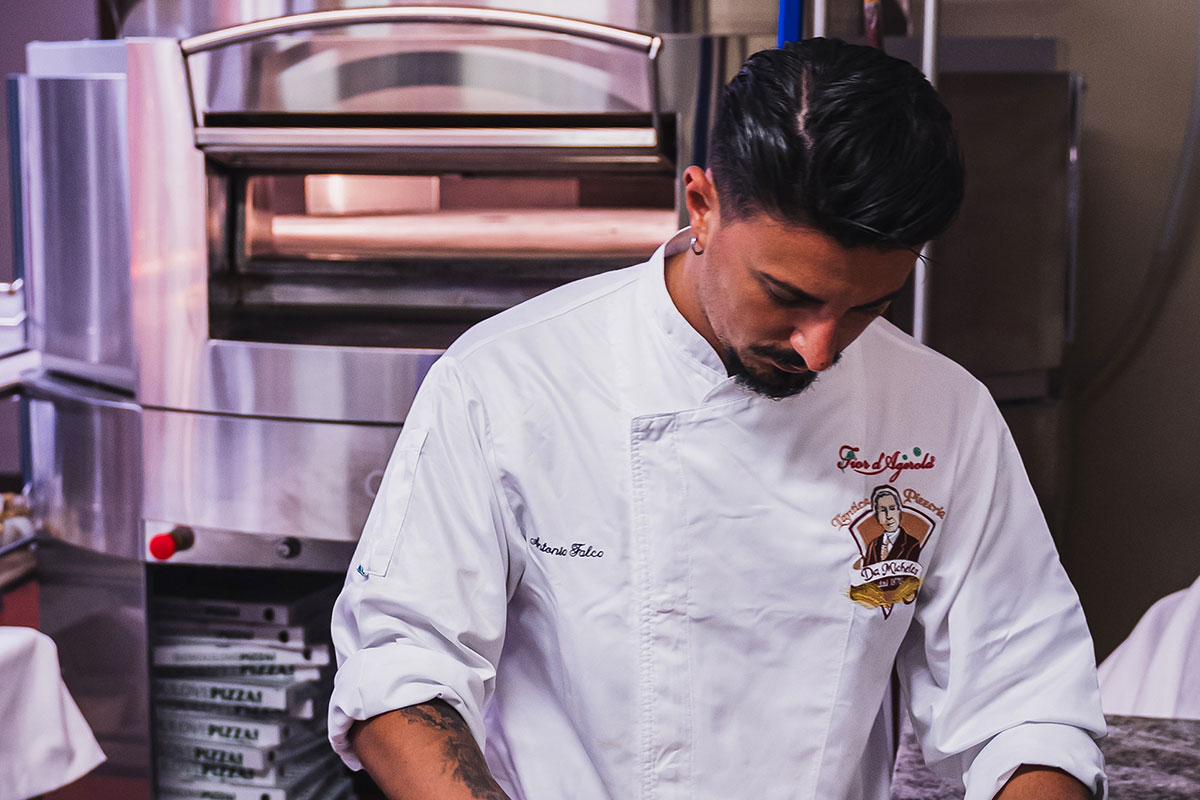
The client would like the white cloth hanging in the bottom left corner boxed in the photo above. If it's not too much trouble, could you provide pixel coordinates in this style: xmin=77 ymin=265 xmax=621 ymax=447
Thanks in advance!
xmin=0 ymin=627 xmax=104 ymax=800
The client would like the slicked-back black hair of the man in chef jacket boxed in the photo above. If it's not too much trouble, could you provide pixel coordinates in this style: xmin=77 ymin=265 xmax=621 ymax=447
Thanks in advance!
xmin=709 ymin=38 xmax=964 ymax=248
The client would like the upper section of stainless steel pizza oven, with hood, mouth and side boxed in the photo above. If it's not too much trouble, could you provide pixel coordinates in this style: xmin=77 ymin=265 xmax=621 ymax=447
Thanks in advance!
xmin=18 ymin=6 xmax=695 ymax=422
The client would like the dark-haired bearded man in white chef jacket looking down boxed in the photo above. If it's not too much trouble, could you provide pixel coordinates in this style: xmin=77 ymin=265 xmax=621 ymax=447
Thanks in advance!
xmin=330 ymin=40 xmax=1104 ymax=800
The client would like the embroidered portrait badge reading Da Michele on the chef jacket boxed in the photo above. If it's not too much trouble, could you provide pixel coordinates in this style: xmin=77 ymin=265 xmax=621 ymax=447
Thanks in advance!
xmin=848 ymin=485 xmax=937 ymax=619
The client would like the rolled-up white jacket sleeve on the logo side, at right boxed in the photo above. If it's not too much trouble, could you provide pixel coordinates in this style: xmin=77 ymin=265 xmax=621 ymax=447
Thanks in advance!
xmin=898 ymin=396 xmax=1108 ymax=800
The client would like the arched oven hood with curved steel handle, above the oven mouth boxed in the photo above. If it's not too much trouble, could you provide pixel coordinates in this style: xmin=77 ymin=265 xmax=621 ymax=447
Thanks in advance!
xmin=181 ymin=6 xmax=673 ymax=169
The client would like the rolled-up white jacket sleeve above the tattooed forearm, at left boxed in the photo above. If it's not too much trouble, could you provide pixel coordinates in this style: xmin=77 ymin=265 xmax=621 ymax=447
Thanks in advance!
xmin=329 ymin=356 xmax=516 ymax=769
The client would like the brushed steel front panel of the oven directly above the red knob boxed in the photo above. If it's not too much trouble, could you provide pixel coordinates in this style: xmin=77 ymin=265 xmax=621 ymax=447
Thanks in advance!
xmin=138 ymin=407 xmax=400 ymax=544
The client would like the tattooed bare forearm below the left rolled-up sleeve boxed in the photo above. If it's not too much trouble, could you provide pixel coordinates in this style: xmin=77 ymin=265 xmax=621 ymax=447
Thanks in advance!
xmin=350 ymin=700 xmax=509 ymax=800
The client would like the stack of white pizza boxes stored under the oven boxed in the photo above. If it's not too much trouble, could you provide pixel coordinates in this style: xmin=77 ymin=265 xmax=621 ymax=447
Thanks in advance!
xmin=151 ymin=582 xmax=352 ymax=800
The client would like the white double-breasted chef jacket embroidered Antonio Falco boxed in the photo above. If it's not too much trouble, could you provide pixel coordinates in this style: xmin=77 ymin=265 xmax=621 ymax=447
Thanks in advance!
xmin=329 ymin=231 xmax=1105 ymax=800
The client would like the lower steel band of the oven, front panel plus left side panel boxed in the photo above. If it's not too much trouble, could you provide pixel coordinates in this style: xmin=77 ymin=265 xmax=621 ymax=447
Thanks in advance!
xmin=24 ymin=378 xmax=400 ymax=556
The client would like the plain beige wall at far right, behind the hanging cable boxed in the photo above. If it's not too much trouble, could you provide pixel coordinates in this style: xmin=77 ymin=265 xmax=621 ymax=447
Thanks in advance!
xmin=942 ymin=0 xmax=1200 ymax=656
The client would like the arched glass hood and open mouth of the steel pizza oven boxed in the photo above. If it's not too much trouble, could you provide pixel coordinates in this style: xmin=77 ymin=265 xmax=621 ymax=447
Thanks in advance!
xmin=194 ymin=7 xmax=677 ymax=362
